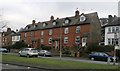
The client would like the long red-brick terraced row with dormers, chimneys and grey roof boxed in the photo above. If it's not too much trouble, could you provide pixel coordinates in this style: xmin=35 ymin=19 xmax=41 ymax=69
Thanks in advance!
xmin=20 ymin=10 xmax=101 ymax=48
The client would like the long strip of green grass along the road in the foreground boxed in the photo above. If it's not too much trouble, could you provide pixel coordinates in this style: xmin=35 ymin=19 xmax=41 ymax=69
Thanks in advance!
xmin=2 ymin=55 xmax=118 ymax=69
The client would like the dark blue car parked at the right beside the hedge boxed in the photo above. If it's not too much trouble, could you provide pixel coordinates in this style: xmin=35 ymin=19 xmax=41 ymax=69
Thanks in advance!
xmin=88 ymin=52 xmax=118 ymax=62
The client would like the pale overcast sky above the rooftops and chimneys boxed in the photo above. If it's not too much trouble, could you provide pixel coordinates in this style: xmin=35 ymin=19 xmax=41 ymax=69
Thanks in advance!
xmin=0 ymin=0 xmax=119 ymax=30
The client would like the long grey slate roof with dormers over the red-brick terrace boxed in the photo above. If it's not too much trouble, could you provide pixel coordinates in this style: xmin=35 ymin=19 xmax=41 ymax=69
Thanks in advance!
xmin=21 ymin=12 xmax=99 ymax=32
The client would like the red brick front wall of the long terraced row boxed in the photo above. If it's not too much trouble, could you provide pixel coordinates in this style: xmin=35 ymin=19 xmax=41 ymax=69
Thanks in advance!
xmin=21 ymin=24 xmax=90 ymax=48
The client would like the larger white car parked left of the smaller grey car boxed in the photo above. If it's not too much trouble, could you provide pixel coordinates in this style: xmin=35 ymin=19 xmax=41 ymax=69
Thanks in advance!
xmin=19 ymin=48 xmax=38 ymax=57
